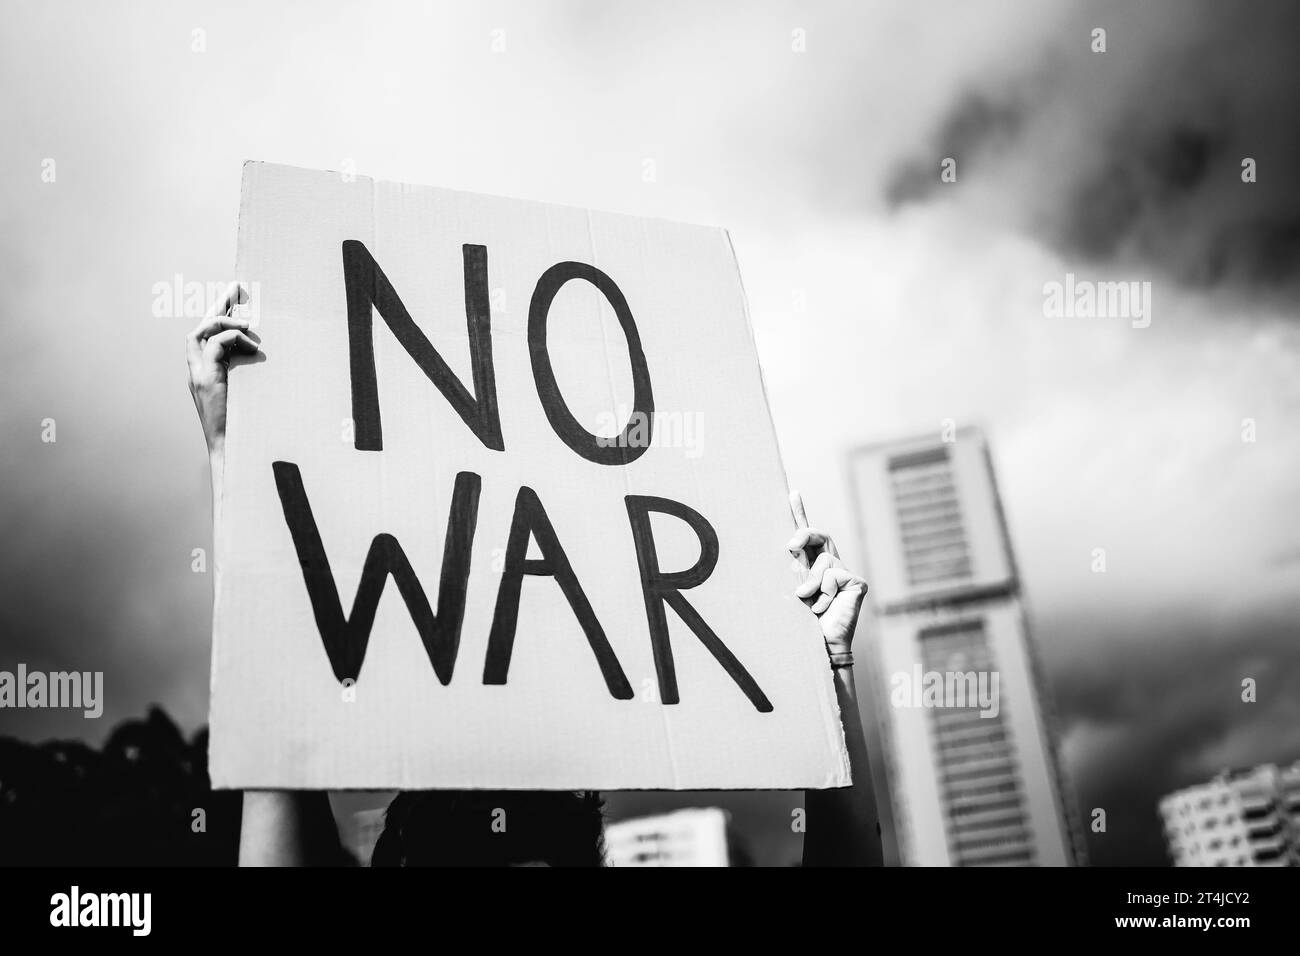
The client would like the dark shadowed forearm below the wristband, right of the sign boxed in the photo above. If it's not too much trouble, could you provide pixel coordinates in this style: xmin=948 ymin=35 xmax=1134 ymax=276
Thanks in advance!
xmin=803 ymin=667 xmax=883 ymax=866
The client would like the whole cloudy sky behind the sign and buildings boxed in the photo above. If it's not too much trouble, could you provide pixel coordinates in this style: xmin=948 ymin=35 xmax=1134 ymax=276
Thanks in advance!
xmin=0 ymin=0 xmax=1300 ymax=864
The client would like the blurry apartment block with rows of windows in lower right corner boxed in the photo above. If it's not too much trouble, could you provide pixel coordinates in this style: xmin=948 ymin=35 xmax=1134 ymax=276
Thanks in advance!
xmin=1160 ymin=761 xmax=1300 ymax=866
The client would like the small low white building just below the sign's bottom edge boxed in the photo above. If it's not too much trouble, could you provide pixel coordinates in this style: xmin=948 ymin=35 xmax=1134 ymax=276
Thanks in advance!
xmin=605 ymin=806 xmax=729 ymax=866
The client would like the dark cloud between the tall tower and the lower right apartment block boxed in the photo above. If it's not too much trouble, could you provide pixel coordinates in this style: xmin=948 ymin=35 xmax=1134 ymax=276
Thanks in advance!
xmin=1043 ymin=607 xmax=1300 ymax=865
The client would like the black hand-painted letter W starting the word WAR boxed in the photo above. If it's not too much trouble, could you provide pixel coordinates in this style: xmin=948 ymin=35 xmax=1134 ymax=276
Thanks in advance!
xmin=270 ymin=462 xmax=482 ymax=685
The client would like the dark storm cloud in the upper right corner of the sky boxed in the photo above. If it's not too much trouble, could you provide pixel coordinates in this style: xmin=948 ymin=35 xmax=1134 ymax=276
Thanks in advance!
xmin=883 ymin=3 xmax=1300 ymax=294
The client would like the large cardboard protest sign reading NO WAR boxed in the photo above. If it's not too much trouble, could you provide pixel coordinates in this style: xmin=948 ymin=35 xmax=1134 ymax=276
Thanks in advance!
xmin=211 ymin=164 xmax=849 ymax=790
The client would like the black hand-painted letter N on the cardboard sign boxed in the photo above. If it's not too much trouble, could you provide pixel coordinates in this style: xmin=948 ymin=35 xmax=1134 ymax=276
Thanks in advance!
xmin=343 ymin=239 xmax=506 ymax=451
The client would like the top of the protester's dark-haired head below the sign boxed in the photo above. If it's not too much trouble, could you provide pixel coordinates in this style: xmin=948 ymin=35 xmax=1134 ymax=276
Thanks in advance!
xmin=371 ymin=790 xmax=605 ymax=866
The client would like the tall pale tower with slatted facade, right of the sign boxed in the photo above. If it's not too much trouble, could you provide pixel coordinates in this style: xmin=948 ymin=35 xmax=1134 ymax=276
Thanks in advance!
xmin=849 ymin=428 xmax=1083 ymax=866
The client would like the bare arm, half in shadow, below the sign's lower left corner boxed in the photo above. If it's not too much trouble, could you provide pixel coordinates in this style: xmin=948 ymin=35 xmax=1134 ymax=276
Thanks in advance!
xmin=239 ymin=790 xmax=346 ymax=866
